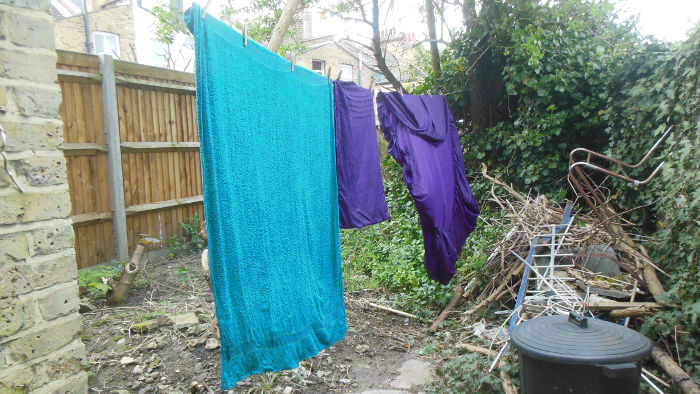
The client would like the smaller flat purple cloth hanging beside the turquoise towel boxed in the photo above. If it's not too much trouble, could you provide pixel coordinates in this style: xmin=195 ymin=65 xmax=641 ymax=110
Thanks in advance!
xmin=333 ymin=81 xmax=389 ymax=228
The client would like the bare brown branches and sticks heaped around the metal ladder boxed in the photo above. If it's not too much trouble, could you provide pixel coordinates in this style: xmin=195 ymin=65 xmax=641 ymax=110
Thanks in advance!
xmin=430 ymin=166 xmax=698 ymax=393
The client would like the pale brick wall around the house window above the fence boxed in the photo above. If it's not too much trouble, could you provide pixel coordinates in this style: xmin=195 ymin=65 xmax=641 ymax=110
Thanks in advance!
xmin=54 ymin=5 xmax=136 ymax=62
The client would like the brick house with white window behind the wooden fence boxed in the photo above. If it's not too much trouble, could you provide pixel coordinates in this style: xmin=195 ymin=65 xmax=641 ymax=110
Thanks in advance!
xmin=51 ymin=0 xmax=194 ymax=71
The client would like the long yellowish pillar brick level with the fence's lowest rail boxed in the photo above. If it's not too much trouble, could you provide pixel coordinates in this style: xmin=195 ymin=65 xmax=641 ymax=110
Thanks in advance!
xmin=0 ymin=190 xmax=70 ymax=225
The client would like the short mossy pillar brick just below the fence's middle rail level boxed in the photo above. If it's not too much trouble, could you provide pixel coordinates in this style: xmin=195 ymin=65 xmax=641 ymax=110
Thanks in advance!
xmin=12 ymin=156 xmax=67 ymax=187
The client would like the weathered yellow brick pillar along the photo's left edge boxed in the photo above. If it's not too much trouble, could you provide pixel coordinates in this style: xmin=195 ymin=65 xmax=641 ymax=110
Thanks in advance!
xmin=0 ymin=0 xmax=87 ymax=393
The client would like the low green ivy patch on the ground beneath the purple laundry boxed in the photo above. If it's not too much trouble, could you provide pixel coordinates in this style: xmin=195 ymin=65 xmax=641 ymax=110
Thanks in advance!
xmin=340 ymin=155 xmax=502 ymax=317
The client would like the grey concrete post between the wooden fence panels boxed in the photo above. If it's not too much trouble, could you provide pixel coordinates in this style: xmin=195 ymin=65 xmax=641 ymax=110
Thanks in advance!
xmin=100 ymin=55 xmax=129 ymax=261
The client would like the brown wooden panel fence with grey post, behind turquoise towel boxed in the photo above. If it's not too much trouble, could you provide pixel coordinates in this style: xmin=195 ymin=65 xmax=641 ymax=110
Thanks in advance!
xmin=57 ymin=51 xmax=203 ymax=268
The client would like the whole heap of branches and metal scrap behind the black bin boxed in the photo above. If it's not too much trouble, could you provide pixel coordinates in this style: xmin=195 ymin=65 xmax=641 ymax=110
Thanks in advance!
xmin=430 ymin=167 xmax=700 ymax=393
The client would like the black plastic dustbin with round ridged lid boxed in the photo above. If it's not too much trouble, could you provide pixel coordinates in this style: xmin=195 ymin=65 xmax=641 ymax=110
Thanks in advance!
xmin=511 ymin=313 xmax=651 ymax=394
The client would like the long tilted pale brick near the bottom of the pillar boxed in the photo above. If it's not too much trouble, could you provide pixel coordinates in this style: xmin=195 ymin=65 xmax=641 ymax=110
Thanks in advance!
xmin=5 ymin=313 xmax=81 ymax=362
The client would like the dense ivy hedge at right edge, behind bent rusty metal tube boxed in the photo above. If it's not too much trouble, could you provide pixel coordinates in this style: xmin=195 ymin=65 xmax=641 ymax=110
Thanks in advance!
xmin=605 ymin=27 xmax=700 ymax=381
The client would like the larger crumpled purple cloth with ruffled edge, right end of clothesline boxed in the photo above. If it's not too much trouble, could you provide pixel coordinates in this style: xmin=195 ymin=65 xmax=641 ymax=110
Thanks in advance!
xmin=377 ymin=92 xmax=479 ymax=284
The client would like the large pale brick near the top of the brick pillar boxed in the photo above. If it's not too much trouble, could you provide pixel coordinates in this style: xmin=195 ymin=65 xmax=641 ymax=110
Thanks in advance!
xmin=7 ymin=12 xmax=55 ymax=49
